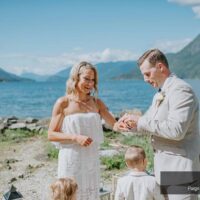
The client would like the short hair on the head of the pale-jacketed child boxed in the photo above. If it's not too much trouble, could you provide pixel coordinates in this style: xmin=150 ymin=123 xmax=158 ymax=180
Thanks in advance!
xmin=125 ymin=145 xmax=146 ymax=167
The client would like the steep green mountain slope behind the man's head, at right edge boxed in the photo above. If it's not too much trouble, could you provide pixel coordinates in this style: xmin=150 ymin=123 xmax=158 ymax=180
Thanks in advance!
xmin=167 ymin=34 xmax=200 ymax=79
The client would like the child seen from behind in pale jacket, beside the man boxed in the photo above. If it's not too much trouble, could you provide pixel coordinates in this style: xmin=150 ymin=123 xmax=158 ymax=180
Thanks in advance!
xmin=115 ymin=145 xmax=164 ymax=200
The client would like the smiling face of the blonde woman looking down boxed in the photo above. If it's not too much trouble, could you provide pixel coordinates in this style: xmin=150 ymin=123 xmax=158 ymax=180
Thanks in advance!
xmin=77 ymin=68 xmax=95 ymax=94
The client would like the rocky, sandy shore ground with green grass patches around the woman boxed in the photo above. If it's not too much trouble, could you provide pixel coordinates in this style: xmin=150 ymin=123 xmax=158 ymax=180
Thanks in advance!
xmin=0 ymin=117 xmax=151 ymax=200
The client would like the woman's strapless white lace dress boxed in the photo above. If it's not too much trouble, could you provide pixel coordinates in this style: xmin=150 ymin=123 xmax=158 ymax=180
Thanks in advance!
xmin=55 ymin=113 xmax=103 ymax=200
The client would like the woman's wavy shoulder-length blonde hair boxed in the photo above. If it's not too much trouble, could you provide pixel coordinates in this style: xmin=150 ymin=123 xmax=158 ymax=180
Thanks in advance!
xmin=66 ymin=61 xmax=98 ymax=96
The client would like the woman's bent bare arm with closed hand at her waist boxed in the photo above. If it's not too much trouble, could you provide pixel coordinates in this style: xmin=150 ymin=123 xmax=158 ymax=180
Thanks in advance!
xmin=48 ymin=97 xmax=92 ymax=146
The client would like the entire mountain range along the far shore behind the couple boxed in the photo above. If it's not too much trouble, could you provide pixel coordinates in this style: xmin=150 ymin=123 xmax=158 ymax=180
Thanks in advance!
xmin=3 ymin=34 xmax=200 ymax=82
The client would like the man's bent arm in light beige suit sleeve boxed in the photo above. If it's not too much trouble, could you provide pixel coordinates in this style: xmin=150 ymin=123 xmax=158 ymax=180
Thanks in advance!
xmin=138 ymin=86 xmax=196 ymax=141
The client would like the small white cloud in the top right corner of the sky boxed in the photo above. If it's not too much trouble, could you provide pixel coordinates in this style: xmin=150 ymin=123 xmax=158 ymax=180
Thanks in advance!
xmin=168 ymin=0 xmax=200 ymax=18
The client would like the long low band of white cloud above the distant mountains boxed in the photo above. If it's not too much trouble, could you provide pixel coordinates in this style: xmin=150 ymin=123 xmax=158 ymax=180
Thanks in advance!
xmin=0 ymin=48 xmax=138 ymax=74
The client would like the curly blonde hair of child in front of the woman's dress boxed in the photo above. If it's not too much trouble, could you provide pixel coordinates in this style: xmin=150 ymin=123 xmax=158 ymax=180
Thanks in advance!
xmin=50 ymin=178 xmax=78 ymax=200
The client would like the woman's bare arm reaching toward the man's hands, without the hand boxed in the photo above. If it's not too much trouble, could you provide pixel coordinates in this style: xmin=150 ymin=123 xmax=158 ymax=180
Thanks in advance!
xmin=97 ymin=99 xmax=117 ymax=127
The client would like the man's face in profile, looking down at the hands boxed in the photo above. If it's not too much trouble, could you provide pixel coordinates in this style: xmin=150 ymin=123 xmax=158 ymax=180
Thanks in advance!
xmin=140 ymin=60 xmax=165 ymax=88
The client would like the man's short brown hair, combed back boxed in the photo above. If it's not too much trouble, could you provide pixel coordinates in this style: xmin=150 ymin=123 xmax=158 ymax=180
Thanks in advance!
xmin=137 ymin=49 xmax=169 ymax=68
